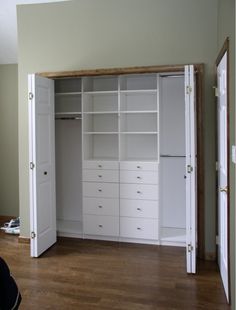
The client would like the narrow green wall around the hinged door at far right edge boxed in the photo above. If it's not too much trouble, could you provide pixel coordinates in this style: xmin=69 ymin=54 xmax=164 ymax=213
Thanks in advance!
xmin=217 ymin=0 xmax=235 ymax=309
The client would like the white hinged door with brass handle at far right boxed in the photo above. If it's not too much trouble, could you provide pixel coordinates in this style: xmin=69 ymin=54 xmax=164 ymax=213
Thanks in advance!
xmin=217 ymin=52 xmax=229 ymax=299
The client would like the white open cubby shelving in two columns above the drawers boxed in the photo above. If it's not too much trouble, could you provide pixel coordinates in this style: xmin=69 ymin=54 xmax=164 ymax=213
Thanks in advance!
xmin=82 ymin=74 xmax=159 ymax=160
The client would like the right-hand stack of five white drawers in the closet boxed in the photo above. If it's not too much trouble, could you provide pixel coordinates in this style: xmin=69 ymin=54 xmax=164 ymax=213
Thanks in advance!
xmin=120 ymin=162 xmax=158 ymax=240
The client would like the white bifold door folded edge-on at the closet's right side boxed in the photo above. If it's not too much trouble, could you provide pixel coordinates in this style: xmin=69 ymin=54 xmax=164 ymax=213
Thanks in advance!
xmin=185 ymin=65 xmax=197 ymax=273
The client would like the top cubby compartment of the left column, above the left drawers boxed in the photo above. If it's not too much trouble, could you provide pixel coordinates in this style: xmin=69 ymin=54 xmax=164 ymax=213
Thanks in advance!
xmin=83 ymin=76 xmax=118 ymax=92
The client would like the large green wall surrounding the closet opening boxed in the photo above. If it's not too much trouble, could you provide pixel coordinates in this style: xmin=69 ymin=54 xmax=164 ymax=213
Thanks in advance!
xmin=17 ymin=0 xmax=218 ymax=253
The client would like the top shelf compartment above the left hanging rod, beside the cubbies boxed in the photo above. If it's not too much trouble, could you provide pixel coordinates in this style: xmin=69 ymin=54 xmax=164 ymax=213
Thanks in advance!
xmin=55 ymin=78 xmax=81 ymax=95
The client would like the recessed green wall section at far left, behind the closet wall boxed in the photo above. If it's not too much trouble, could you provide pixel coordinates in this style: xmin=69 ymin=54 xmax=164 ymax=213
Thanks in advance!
xmin=0 ymin=64 xmax=19 ymax=216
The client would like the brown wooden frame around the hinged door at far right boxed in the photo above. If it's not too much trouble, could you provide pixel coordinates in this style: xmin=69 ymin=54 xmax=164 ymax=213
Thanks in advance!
xmin=215 ymin=37 xmax=231 ymax=304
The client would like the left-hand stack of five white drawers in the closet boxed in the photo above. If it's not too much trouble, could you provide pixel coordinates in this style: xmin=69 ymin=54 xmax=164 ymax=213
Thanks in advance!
xmin=83 ymin=161 xmax=119 ymax=237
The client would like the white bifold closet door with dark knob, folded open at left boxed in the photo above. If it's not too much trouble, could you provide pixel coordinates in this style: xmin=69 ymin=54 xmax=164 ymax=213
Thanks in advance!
xmin=28 ymin=75 xmax=56 ymax=257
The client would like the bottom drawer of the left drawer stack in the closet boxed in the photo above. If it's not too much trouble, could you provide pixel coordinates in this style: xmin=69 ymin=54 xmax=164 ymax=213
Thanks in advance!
xmin=84 ymin=214 xmax=119 ymax=236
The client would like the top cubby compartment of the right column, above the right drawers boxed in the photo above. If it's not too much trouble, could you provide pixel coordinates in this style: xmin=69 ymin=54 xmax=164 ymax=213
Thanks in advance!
xmin=120 ymin=74 xmax=157 ymax=91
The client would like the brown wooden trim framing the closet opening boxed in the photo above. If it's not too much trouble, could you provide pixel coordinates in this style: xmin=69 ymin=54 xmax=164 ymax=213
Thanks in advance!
xmin=37 ymin=63 xmax=206 ymax=259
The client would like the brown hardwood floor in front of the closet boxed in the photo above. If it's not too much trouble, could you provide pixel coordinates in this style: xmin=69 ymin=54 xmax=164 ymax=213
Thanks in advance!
xmin=0 ymin=232 xmax=230 ymax=310
